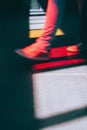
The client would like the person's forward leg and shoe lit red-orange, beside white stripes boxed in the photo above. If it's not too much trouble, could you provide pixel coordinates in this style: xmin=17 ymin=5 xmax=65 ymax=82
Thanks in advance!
xmin=16 ymin=0 xmax=65 ymax=60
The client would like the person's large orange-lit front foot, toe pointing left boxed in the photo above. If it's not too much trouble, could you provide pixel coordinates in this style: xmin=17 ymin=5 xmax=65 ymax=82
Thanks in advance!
xmin=15 ymin=43 xmax=49 ymax=60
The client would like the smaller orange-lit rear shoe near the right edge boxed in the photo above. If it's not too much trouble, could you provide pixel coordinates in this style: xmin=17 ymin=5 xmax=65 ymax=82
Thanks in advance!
xmin=67 ymin=43 xmax=87 ymax=53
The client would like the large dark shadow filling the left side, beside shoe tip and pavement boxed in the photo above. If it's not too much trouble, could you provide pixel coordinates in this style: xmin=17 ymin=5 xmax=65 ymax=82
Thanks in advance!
xmin=0 ymin=0 xmax=35 ymax=130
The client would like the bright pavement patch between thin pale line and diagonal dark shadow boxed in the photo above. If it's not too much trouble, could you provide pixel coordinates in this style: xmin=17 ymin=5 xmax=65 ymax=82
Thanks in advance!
xmin=33 ymin=71 xmax=87 ymax=119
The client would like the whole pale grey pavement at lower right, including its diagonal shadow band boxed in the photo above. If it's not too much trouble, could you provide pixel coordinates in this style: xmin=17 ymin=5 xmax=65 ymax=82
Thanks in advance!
xmin=33 ymin=65 xmax=87 ymax=130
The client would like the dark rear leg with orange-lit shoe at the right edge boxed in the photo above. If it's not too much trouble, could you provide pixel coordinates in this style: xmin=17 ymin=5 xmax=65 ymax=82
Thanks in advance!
xmin=67 ymin=0 xmax=87 ymax=52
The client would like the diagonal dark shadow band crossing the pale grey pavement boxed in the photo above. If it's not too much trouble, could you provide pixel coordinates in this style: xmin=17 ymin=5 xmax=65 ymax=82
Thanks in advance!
xmin=36 ymin=107 xmax=87 ymax=130
